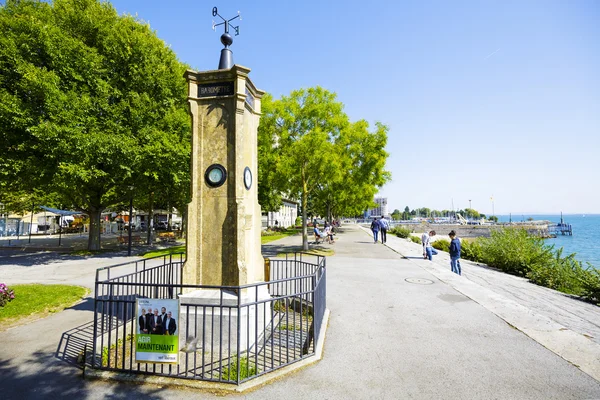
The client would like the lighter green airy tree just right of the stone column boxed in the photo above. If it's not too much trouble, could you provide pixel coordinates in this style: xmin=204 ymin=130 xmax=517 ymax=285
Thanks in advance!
xmin=259 ymin=87 xmax=389 ymax=250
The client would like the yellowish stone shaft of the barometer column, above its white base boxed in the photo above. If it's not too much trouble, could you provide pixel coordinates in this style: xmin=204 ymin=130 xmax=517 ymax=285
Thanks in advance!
xmin=184 ymin=65 xmax=264 ymax=286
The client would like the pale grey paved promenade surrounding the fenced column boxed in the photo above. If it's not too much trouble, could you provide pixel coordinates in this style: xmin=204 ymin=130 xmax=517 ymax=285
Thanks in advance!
xmin=0 ymin=225 xmax=600 ymax=400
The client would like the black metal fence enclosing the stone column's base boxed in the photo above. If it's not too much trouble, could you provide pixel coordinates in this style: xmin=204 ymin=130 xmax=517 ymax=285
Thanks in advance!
xmin=92 ymin=253 xmax=326 ymax=384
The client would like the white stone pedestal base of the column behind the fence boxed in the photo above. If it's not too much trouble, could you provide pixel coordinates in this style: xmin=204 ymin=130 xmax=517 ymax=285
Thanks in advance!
xmin=179 ymin=285 xmax=272 ymax=356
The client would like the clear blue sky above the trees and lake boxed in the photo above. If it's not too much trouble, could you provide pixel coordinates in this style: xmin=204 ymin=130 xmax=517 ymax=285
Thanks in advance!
xmin=111 ymin=0 xmax=600 ymax=214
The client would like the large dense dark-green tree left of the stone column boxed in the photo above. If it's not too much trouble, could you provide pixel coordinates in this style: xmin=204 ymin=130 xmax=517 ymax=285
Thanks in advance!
xmin=0 ymin=0 xmax=189 ymax=250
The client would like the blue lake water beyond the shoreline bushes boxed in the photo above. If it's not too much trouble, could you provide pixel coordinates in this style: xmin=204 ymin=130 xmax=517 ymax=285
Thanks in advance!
xmin=498 ymin=214 xmax=600 ymax=268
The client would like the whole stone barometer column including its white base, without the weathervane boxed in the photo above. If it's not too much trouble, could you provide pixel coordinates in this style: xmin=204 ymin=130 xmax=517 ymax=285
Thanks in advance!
xmin=180 ymin=66 xmax=271 ymax=354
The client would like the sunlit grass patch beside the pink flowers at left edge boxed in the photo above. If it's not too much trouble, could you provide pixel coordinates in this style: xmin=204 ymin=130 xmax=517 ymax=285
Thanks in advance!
xmin=0 ymin=284 xmax=90 ymax=329
